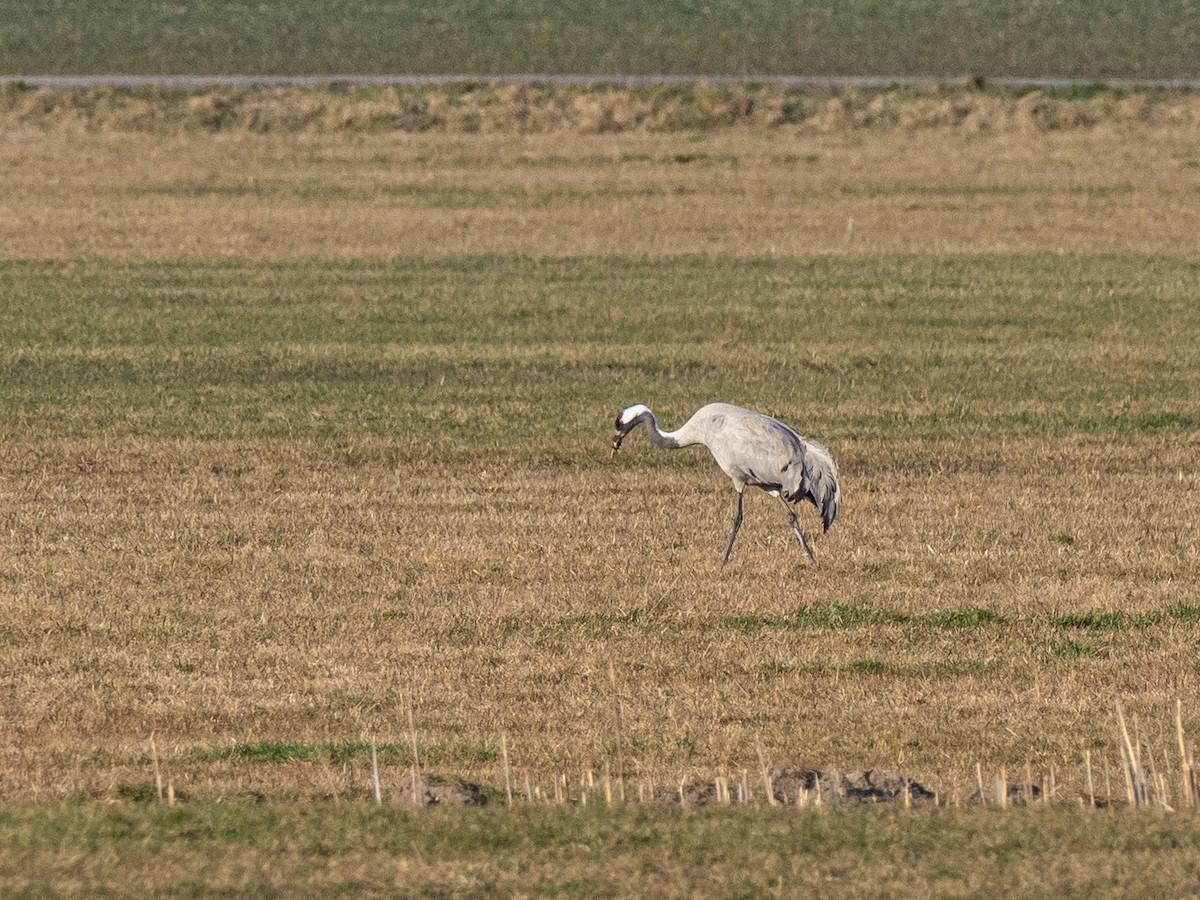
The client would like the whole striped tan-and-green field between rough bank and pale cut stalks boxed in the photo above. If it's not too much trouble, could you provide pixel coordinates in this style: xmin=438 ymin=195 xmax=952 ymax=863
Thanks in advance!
xmin=0 ymin=86 xmax=1200 ymax=889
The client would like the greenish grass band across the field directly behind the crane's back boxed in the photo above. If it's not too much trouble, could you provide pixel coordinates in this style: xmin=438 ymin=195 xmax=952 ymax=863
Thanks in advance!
xmin=0 ymin=256 xmax=1200 ymax=453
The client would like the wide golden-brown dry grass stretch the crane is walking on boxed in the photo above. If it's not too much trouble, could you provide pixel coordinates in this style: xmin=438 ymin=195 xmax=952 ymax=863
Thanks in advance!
xmin=0 ymin=438 xmax=1200 ymax=797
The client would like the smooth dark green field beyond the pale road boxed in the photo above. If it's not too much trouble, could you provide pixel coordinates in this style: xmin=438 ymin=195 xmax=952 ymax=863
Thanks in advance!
xmin=7 ymin=0 xmax=1200 ymax=78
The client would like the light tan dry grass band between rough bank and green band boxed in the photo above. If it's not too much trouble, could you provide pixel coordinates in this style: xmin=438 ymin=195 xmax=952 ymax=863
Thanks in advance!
xmin=0 ymin=125 xmax=1200 ymax=260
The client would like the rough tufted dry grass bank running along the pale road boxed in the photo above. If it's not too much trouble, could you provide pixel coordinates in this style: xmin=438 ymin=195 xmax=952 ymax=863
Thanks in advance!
xmin=7 ymin=83 xmax=1200 ymax=134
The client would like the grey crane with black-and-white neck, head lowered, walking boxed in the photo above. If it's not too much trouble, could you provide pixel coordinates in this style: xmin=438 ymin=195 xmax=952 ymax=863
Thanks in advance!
xmin=612 ymin=403 xmax=841 ymax=566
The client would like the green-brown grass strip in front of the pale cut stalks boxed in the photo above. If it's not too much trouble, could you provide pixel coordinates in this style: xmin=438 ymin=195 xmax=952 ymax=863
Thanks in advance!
xmin=7 ymin=803 xmax=1200 ymax=898
